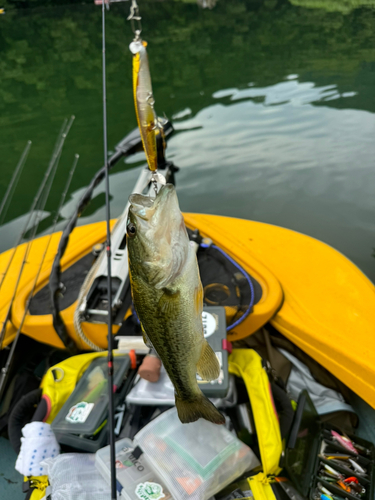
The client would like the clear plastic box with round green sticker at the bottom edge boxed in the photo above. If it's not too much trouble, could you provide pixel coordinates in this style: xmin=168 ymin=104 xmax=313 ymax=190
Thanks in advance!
xmin=95 ymin=438 xmax=172 ymax=500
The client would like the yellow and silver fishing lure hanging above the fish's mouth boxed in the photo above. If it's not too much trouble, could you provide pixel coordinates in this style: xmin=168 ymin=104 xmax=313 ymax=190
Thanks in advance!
xmin=130 ymin=40 xmax=158 ymax=172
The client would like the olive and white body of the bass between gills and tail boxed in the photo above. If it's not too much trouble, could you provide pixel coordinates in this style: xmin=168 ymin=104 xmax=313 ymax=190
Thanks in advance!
xmin=132 ymin=244 xmax=204 ymax=398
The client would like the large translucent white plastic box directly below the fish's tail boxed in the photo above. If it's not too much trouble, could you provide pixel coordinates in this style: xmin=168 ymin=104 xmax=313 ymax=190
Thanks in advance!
xmin=134 ymin=408 xmax=260 ymax=500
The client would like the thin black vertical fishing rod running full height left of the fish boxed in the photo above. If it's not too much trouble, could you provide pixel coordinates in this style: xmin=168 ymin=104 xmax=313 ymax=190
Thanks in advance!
xmin=102 ymin=2 xmax=117 ymax=500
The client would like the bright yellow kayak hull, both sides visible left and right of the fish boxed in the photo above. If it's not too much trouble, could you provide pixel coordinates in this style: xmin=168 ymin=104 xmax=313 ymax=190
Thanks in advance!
xmin=0 ymin=214 xmax=375 ymax=408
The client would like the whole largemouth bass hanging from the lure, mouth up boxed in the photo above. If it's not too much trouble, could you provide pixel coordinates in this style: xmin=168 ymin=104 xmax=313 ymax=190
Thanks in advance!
xmin=127 ymin=184 xmax=225 ymax=424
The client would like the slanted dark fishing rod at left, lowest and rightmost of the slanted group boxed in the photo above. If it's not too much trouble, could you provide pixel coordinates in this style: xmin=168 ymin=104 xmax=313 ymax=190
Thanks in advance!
xmin=0 ymin=154 xmax=79 ymax=401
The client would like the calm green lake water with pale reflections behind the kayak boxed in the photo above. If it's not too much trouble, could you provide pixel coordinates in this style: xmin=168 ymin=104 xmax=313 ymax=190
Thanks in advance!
xmin=0 ymin=0 xmax=375 ymax=281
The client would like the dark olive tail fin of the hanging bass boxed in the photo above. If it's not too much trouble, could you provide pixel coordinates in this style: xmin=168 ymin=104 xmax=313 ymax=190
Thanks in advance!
xmin=176 ymin=393 xmax=225 ymax=424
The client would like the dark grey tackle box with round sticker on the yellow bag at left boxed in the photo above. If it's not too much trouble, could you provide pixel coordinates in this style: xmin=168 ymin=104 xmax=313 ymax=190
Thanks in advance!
xmin=51 ymin=354 xmax=131 ymax=453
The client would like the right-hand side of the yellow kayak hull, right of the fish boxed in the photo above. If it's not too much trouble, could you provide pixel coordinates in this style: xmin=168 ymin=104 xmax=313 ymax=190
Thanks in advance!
xmin=187 ymin=215 xmax=375 ymax=408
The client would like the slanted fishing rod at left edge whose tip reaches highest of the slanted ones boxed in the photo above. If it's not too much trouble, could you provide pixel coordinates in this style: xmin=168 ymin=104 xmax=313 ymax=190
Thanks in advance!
xmin=0 ymin=116 xmax=75 ymax=294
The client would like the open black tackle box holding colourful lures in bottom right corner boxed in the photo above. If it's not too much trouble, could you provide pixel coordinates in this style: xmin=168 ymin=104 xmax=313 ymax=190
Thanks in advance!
xmin=280 ymin=390 xmax=375 ymax=500
